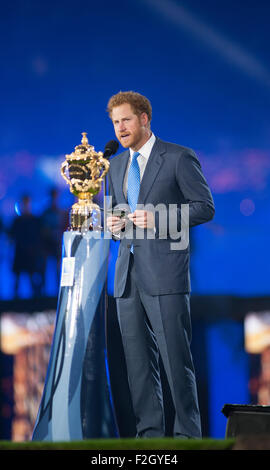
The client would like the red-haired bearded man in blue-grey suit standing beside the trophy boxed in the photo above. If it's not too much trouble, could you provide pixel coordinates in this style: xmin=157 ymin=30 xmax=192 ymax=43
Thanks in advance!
xmin=107 ymin=92 xmax=215 ymax=438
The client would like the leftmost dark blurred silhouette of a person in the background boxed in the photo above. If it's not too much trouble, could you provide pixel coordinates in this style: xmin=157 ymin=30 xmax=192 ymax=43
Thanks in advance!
xmin=8 ymin=194 xmax=44 ymax=297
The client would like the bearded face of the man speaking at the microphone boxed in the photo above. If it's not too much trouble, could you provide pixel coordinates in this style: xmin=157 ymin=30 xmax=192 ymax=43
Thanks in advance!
xmin=111 ymin=103 xmax=149 ymax=150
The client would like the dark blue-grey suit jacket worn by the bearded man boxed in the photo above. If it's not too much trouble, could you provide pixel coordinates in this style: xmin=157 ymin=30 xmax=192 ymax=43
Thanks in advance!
xmin=108 ymin=138 xmax=215 ymax=297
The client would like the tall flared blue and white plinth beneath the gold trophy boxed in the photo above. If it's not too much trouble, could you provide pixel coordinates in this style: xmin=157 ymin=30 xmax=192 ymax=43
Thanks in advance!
xmin=32 ymin=231 xmax=118 ymax=441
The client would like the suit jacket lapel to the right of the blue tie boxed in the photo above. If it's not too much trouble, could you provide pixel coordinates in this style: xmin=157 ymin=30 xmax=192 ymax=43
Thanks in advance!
xmin=138 ymin=138 xmax=166 ymax=204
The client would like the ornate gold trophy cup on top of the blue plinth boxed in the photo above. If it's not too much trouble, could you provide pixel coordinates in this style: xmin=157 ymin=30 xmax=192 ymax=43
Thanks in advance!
xmin=61 ymin=132 xmax=110 ymax=231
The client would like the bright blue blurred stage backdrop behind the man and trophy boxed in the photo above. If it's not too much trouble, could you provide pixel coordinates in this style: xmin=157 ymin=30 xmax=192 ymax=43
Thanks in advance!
xmin=0 ymin=0 xmax=270 ymax=440
